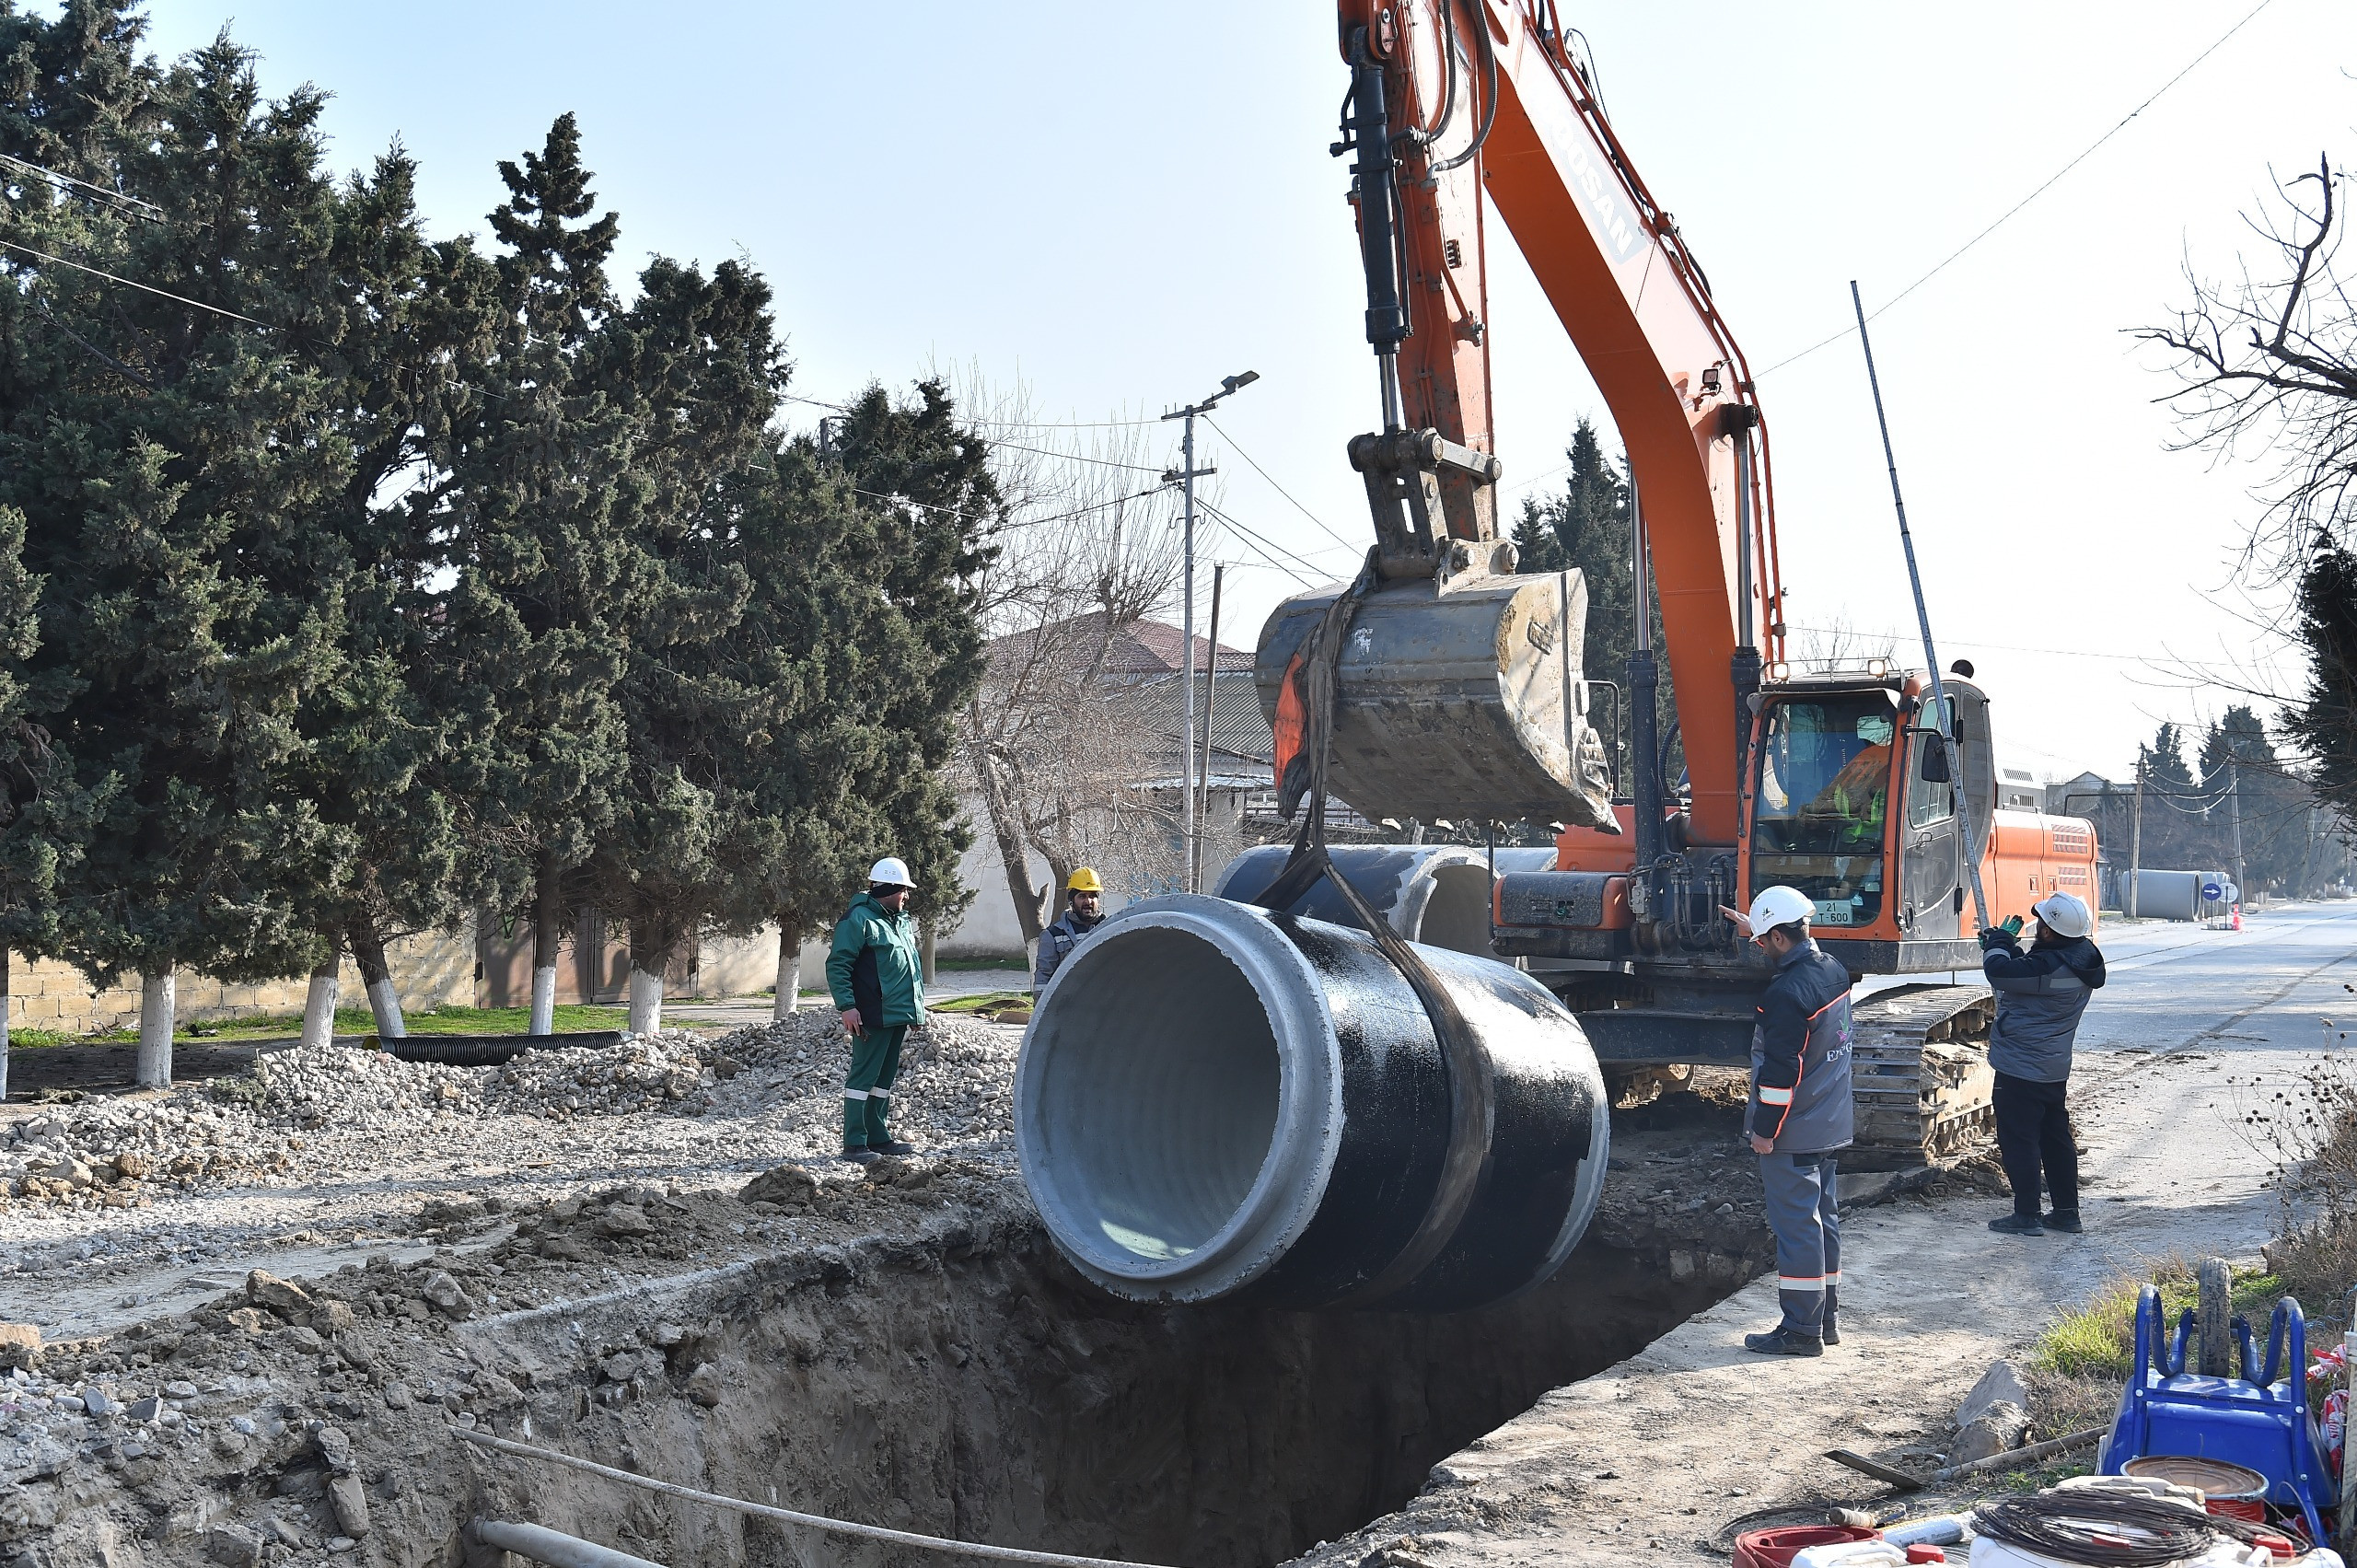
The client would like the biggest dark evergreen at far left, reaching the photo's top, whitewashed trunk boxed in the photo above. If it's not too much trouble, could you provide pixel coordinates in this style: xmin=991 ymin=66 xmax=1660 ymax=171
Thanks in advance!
xmin=0 ymin=27 xmax=346 ymax=1082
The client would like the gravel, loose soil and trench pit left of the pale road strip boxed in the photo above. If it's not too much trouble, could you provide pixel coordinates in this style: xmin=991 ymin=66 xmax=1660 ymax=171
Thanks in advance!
xmin=0 ymin=1023 xmax=1895 ymax=1568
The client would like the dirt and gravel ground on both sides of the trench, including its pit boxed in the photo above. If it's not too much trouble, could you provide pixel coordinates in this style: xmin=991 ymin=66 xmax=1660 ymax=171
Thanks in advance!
xmin=0 ymin=912 xmax=2357 ymax=1568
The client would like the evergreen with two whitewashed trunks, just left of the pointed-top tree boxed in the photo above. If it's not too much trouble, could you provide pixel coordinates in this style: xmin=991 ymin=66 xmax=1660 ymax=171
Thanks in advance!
xmin=285 ymin=146 xmax=511 ymax=1040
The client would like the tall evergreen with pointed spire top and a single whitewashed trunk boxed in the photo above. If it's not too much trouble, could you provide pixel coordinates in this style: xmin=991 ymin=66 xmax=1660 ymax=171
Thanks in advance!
xmin=443 ymin=113 xmax=648 ymax=1033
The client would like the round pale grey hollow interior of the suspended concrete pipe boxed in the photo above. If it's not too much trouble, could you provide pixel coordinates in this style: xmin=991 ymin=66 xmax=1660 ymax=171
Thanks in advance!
xmin=1039 ymin=926 xmax=1283 ymax=1261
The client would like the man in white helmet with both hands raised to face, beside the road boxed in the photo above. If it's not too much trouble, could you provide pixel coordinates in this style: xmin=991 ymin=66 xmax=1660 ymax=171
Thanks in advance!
xmin=1980 ymin=894 xmax=2103 ymax=1236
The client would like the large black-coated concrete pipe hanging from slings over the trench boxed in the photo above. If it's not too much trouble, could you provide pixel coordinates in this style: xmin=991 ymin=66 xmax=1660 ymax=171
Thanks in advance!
xmin=1016 ymin=894 xmax=1609 ymax=1311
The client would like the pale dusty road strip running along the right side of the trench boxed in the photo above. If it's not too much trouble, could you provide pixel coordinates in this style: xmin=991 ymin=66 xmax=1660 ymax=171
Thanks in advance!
xmin=1304 ymin=903 xmax=2357 ymax=1568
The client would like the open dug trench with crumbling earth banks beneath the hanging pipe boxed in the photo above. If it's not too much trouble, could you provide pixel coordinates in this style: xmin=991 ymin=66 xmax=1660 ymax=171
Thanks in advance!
xmin=0 ymin=1074 xmax=1819 ymax=1568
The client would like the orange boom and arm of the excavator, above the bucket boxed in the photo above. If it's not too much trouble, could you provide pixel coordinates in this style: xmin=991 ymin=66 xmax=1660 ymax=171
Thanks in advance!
xmin=1337 ymin=0 xmax=1782 ymax=844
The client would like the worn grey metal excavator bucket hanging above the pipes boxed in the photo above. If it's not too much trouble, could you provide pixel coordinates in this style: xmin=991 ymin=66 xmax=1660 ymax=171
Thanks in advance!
xmin=1254 ymin=571 xmax=1620 ymax=832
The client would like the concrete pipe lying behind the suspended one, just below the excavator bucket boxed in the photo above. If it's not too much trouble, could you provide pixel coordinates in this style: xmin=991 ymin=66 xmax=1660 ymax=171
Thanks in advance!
xmin=1212 ymin=844 xmax=1556 ymax=958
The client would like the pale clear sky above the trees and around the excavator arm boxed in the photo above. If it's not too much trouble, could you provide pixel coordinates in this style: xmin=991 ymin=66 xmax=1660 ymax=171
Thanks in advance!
xmin=129 ymin=0 xmax=2357 ymax=778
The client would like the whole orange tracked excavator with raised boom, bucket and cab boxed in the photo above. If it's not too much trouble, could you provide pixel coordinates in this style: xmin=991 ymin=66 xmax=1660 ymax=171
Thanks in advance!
xmin=1221 ymin=0 xmax=2096 ymax=1163
